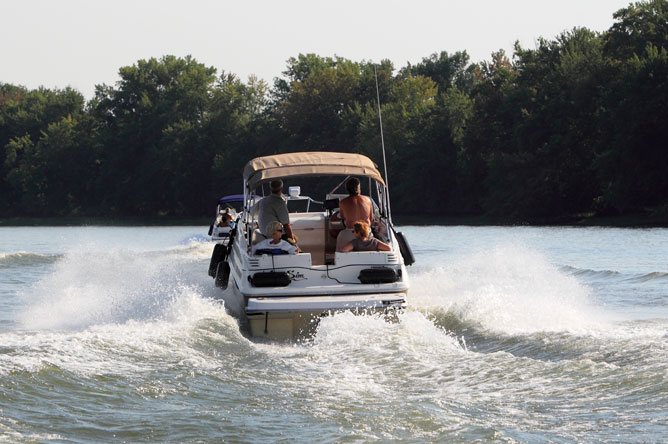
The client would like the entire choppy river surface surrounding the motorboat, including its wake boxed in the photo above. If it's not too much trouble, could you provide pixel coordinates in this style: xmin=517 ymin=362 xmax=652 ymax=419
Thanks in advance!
xmin=0 ymin=226 xmax=668 ymax=443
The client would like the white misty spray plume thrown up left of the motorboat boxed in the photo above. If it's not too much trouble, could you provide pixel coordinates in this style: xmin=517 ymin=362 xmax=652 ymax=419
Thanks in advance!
xmin=18 ymin=243 xmax=217 ymax=330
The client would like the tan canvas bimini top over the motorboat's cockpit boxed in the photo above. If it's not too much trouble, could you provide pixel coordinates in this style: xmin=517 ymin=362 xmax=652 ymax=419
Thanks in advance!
xmin=244 ymin=151 xmax=385 ymax=189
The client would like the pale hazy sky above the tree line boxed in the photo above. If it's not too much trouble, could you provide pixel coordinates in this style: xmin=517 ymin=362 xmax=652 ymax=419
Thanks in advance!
xmin=0 ymin=0 xmax=630 ymax=99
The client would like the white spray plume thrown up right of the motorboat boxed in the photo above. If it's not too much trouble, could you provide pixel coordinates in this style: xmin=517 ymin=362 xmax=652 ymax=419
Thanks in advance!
xmin=411 ymin=245 xmax=612 ymax=335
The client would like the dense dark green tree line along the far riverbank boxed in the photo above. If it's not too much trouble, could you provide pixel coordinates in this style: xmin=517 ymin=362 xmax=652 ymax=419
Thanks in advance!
xmin=0 ymin=0 xmax=668 ymax=222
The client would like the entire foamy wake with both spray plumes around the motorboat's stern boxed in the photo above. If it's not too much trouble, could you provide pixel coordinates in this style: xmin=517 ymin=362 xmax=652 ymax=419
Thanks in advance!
xmin=0 ymin=236 xmax=668 ymax=416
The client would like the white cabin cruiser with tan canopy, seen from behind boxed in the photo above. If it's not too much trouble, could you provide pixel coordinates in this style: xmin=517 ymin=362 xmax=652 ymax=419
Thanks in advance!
xmin=209 ymin=152 xmax=414 ymax=340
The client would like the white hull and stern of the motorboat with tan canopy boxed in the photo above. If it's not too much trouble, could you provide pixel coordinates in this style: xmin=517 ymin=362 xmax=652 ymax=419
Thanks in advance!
xmin=223 ymin=213 xmax=409 ymax=339
